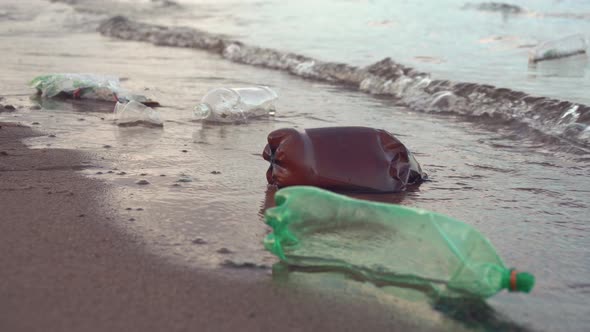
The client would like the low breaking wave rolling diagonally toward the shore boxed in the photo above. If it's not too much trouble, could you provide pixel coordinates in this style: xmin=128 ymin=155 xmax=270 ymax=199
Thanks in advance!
xmin=98 ymin=16 xmax=590 ymax=151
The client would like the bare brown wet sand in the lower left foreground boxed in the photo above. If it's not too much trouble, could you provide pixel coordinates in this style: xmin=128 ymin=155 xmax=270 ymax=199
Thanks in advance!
xmin=0 ymin=123 xmax=434 ymax=332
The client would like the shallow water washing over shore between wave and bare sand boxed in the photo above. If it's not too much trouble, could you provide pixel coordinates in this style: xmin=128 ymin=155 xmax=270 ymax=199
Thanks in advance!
xmin=0 ymin=0 xmax=590 ymax=331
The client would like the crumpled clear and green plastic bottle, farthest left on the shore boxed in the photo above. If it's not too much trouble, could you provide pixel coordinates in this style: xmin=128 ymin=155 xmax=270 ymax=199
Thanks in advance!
xmin=30 ymin=73 xmax=159 ymax=106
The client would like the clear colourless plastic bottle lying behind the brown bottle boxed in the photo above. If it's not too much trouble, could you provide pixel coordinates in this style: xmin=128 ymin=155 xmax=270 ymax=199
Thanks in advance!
xmin=194 ymin=86 xmax=278 ymax=123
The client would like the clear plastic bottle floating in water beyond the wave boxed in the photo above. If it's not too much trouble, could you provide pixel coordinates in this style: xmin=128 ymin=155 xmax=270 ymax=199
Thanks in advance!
xmin=529 ymin=35 xmax=588 ymax=63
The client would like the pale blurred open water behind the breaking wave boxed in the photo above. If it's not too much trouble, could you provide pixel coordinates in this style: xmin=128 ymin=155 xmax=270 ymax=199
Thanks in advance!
xmin=154 ymin=0 xmax=590 ymax=104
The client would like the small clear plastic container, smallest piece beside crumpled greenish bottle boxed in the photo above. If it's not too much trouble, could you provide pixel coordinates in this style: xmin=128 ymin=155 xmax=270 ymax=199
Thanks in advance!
xmin=114 ymin=101 xmax=164 ymax=127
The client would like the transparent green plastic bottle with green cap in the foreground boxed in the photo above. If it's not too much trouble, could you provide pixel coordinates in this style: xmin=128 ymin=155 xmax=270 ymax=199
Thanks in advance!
xmin=264 ymin=186 xmax=535 ymax=298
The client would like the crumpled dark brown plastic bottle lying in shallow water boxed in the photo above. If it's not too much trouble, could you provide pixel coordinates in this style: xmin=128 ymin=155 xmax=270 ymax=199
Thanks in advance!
xmin=263 ymin=127 xmax=426 ymax=192
